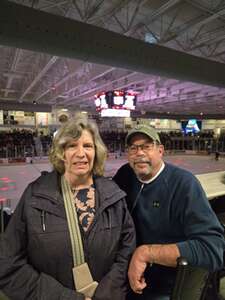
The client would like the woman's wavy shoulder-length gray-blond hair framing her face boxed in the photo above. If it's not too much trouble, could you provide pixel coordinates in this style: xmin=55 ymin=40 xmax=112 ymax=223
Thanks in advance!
xmin=49 ymin=114 xmax=107 ymax=176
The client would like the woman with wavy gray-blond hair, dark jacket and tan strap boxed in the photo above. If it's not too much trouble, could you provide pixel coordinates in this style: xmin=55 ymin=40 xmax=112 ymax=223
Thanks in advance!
xmin=0 ymin=116 xmax=135 ymax=300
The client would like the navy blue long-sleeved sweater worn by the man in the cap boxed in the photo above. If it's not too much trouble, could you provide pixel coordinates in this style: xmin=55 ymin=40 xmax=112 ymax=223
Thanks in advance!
xmin=114 ymin=163 xmax=225 ymax=292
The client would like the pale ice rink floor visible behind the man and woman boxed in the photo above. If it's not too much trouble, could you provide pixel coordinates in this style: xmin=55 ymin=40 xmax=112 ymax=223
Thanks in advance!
xmin=0 ymin=155 xmax=225 ymax=210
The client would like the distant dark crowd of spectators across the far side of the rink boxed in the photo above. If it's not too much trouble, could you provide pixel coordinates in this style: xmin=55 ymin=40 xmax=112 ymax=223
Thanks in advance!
xmin=0 ymin=129 xmax=225 ymax=158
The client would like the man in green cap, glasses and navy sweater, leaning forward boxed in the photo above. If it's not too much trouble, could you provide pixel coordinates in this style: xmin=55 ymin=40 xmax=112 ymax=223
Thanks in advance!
xmin=114 ymin=125 xmax=225 ymax=300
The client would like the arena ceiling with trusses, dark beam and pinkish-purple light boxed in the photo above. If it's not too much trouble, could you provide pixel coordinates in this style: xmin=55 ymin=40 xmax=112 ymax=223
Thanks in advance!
xmin=0 ymin=0 xmax=225 ymax=119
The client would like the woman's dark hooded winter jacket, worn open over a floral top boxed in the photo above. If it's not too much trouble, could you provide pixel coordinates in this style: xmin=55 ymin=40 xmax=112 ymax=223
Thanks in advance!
xmin=0 ymin=171 xmax=135 ymax=300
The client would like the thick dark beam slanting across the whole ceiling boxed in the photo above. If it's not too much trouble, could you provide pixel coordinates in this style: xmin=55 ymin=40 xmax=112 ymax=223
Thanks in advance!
xmin=0 ymin=0 xmax=225 ymax=87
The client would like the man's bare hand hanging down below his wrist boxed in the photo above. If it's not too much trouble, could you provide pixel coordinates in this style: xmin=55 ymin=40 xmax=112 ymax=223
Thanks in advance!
xmin=128 ymin=245 xmax=149 ymax=294
